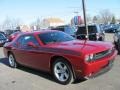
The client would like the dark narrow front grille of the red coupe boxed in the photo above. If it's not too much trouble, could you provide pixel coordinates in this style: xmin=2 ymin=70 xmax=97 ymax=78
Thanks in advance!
xmin=94 ymin=48 xmax=115 ymax=60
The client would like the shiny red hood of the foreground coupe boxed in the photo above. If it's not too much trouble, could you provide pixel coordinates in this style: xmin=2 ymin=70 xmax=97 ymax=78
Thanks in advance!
xmin=46 ymin=40 xmax=113 ymax=53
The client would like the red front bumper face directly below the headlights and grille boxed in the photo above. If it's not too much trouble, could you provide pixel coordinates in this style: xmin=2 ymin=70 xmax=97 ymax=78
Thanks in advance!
xmin=84 ymin=50 xmax=117 ymax=77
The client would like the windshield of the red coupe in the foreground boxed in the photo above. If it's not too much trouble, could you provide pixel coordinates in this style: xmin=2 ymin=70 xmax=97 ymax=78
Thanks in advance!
xmin=39 ymin=32 xmax=75 ymax=44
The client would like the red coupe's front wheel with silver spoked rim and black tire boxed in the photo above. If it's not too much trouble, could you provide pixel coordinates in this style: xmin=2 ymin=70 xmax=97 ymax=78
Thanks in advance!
xmin=52 ymin=58 xmax=74 ymax=85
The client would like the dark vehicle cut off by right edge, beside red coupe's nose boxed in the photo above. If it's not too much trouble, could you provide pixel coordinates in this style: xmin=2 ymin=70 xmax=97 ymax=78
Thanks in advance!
xmin=113 ymin=27 xmax=120 ymax=53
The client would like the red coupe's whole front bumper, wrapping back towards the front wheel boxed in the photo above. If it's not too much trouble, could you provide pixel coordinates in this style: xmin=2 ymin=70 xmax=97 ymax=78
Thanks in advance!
xmin=77 ymin=50 xmax=117 ymax=78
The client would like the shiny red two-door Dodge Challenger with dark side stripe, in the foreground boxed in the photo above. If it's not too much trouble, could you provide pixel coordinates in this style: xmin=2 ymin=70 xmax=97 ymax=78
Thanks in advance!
xmin=4 ymin=30 xmax=117 ymax=84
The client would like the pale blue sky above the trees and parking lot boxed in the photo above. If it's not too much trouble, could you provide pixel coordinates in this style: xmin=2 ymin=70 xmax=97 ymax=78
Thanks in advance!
xmin=0 ymin=0 xmax=120 ymax=23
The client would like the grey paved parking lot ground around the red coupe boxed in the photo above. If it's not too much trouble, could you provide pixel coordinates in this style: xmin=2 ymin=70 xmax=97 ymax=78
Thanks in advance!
xmin=0 ymin=34 xmax=120 ymax=90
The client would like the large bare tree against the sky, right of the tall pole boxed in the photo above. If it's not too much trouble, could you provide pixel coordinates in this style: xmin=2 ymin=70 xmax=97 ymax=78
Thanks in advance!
xmin=100 ymin=10 xmax=113 ymax=24
